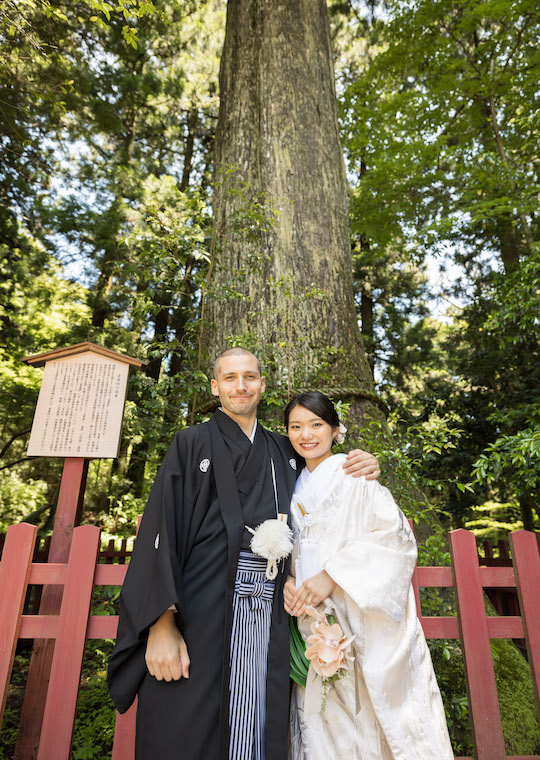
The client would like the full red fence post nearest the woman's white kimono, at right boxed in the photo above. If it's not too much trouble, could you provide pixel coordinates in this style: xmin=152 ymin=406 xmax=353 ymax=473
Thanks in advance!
xmin=450 ymin=529 xmax=506 ymax=760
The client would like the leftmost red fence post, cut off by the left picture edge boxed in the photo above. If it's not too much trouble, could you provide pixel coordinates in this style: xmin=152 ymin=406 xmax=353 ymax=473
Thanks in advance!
xmin=0 ymin=523 xmax=37 ymax=725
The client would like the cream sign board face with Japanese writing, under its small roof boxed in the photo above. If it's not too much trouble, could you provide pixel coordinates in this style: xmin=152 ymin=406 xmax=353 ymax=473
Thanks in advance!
xmin=27 ymin=352 xmax=129 ymax=458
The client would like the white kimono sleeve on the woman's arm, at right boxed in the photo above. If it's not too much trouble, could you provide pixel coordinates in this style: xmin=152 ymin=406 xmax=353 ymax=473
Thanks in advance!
xmin=323 ymin=476 xmax=417 ymax=623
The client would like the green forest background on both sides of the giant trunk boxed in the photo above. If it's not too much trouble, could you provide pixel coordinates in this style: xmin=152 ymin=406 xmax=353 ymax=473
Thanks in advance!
xmin=0 ymin=0 xmax=540 ymax=758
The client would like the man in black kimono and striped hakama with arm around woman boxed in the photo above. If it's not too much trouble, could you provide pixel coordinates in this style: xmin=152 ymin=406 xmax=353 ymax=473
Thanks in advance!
xmin=108 ymin=348 xmax=379 ymax=760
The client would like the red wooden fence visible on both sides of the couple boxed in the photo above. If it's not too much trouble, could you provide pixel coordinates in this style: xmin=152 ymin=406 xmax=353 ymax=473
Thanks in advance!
xmin=0 ymin=524 xmax=540 ymax=760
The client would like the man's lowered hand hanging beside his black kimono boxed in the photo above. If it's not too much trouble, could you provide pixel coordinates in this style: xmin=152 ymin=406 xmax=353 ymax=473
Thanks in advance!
xmin=145 ymin=610 xmax=190 ymax=681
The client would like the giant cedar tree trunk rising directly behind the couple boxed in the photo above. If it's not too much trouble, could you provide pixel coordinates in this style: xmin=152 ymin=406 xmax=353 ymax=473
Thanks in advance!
xmin=204 ymin=0 xmax=386 ymax=416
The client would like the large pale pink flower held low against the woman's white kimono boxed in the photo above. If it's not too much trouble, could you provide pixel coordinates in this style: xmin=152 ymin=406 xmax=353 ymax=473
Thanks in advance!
xmin=306 ymin=607 xmax=355 ymax=678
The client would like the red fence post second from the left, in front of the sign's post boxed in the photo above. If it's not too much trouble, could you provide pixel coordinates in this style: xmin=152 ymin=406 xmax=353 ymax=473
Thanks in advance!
xmin=38 ymin=525 xmax=100 ymax=760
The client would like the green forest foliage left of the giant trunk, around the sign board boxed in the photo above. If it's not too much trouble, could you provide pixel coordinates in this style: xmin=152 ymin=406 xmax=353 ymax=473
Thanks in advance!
xmin=0 ymin=0 xmax=224 ymax=516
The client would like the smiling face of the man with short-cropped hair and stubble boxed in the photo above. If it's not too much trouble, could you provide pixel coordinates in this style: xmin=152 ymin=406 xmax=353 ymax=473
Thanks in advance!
xmin=211 ymin=354 xmax=264 ymax=417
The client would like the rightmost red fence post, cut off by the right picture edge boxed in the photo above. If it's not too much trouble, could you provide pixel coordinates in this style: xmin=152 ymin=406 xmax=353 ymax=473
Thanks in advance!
xmin=510 ymin=530 xmax=540 ymax=719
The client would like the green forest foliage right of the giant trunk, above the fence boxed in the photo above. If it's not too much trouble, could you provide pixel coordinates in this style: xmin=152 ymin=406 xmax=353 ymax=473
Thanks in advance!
xmin=332 ymin=0 xmax=540 ymax=527
